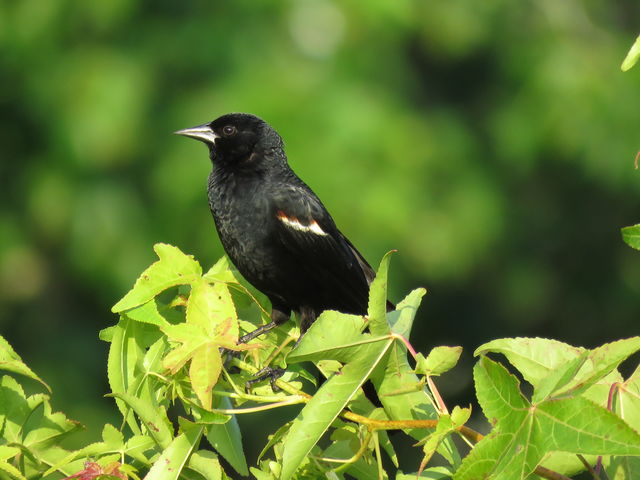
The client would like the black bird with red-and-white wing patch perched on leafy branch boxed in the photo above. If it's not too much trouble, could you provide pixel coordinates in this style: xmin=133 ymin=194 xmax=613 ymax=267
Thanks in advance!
xmin=176 ymin=113 xmax=375 ymax=343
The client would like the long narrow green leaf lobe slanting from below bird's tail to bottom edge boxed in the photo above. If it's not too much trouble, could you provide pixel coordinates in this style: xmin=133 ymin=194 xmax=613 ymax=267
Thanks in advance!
xmin=280 ymin=338 xmax=394 ymax=480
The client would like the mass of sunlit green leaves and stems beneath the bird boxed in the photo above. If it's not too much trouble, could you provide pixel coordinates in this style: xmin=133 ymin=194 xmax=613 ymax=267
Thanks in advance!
xmin=0 ymin=244 xmax=640 ymax=480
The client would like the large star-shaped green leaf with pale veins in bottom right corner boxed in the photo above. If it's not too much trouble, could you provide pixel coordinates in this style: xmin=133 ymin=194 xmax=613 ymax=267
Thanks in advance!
xmin=454 ymin=357 xmax=640 ymax=480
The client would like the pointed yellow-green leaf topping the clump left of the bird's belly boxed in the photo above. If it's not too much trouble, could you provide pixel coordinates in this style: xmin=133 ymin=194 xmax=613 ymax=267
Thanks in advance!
xmin=111 ymin=243 xmax=202 ymax=313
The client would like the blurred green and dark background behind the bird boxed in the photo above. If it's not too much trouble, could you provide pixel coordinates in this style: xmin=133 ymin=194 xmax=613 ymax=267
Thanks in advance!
xmin=0 ymin=0 xmax=640 ymax=472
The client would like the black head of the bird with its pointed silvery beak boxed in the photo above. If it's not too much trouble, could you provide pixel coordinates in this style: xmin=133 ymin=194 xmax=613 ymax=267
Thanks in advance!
xmin=175 ymin=113 xmax=282 ymax=164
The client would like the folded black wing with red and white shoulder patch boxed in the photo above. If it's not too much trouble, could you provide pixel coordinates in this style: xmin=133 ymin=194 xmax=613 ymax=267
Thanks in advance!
xmin=273 ymin=186 xmax=375 ymax=314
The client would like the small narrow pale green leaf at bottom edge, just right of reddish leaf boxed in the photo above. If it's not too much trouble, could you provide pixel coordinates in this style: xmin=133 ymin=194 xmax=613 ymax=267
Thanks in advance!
xmin=144 ymin=425 xmax=204 ymax=480
